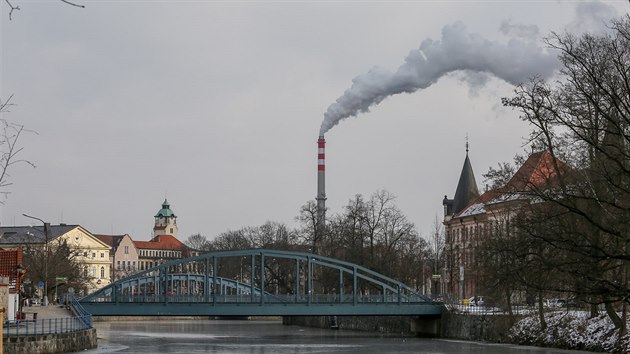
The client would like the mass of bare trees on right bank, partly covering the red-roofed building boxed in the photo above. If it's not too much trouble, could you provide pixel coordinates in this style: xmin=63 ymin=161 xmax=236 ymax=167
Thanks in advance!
xmin=479 ymin=16 xmax=630 ymax=334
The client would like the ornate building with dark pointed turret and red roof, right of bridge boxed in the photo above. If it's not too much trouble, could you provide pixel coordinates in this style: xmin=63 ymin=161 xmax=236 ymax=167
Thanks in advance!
xmin=442 ymin=151 xmax=554 ymax=300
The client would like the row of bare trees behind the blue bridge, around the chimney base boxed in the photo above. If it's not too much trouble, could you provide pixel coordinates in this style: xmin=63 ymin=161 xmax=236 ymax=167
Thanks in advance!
xmin=186 ymin=190 xmax=442 ymax=293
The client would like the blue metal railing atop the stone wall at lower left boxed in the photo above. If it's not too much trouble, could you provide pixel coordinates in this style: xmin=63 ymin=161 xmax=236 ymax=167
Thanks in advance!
xmin=2 ymin=294 xmax=92 ymax=337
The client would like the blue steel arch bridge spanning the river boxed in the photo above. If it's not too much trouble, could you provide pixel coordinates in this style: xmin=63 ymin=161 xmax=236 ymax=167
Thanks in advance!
xmin=79 ymin=249 xmax=442 ymax=318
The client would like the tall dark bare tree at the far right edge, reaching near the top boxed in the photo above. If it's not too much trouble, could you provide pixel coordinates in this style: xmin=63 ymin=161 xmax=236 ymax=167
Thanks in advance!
xmin=503 ymin=16 xmax=630 ymax=333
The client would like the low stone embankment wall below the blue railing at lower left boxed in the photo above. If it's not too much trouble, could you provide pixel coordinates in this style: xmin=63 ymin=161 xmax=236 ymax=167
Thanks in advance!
xmin=2 ymin=328 xmax=97 ymax=354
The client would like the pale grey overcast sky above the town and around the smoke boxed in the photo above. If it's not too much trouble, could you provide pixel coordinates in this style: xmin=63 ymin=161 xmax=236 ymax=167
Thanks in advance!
xmin=0 ymin=0 xmax=630 ymax=240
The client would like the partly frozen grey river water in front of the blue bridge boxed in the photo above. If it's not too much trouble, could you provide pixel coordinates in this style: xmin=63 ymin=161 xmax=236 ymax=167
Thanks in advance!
xmin=83 ymin=319 xmax=596 ymax=354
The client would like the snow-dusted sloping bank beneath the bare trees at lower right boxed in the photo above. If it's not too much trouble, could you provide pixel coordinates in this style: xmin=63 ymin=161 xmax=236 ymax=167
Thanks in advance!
xmin=510 ymin=311 xmax=630 ymax=353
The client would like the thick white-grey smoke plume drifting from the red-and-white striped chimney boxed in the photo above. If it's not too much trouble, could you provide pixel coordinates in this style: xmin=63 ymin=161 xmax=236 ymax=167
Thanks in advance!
xmin=319 ymin=22 xmax=559 ymax=135
